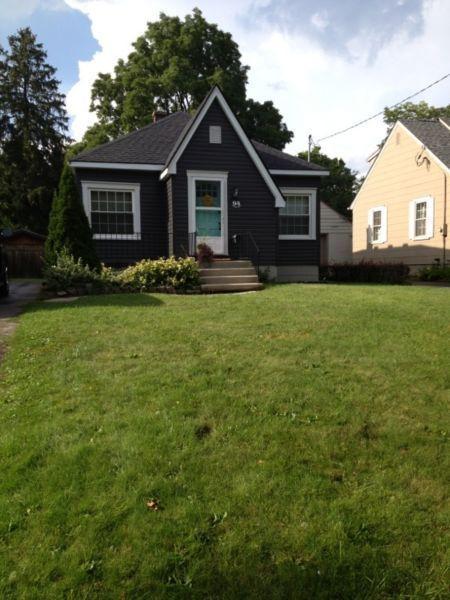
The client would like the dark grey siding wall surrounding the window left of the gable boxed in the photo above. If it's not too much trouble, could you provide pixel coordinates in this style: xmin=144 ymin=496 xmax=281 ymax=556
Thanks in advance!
xmin=76 ymin=168 xmax=168 ymax=266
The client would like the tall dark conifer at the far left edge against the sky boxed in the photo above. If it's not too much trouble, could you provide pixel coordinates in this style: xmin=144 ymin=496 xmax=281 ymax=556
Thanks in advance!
xmin=0 ymin=28 xmax=68 ymax=233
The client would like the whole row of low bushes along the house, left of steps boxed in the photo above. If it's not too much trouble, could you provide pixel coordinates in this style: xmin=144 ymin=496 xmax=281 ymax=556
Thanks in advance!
xmin=44 ymin=249 xmax=199 ymax=295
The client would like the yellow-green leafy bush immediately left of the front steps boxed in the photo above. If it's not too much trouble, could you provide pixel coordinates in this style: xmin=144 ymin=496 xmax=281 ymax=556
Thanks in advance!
xmin=118 ymin=257 xmax=200 ymax=291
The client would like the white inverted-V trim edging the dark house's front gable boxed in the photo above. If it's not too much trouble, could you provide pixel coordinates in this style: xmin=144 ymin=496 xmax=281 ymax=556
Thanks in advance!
xmin=161 ymin=87 xmax=285 ymax=208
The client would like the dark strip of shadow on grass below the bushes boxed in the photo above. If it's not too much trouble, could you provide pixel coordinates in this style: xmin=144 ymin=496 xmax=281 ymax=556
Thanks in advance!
xmin=25 ymin=294 xmax=164 ymax=312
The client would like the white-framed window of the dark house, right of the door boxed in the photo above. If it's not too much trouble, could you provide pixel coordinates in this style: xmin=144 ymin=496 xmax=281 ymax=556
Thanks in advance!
xmin=279 ymin=189 xmax=316 ymax=240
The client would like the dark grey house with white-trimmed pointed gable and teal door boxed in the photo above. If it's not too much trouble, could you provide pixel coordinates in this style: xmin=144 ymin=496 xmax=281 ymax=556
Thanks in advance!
xmin=71 ymin=87 xmax=328 ymax=290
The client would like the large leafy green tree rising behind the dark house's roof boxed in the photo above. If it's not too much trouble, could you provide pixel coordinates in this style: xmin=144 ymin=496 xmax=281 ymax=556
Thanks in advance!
xmin=84 ymin=9 xmax=293 ymax=149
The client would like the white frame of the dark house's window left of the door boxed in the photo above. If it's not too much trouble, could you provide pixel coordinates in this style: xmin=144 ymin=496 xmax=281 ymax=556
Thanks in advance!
xmin=81 ymin=181 xmax=141 ymax=240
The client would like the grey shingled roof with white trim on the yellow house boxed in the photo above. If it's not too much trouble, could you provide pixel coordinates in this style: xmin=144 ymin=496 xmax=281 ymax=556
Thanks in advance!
xmin=349 ymin=118 xmax=450 ymax=210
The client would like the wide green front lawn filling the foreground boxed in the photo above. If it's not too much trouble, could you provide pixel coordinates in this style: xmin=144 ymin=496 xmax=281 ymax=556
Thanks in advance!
xmin=0 ymin=285 xmax=450 ymax=600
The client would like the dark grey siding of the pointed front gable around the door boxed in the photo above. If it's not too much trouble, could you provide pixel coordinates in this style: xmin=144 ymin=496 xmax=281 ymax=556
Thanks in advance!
xmin=173 ymin=101 xmax=278 ymax=265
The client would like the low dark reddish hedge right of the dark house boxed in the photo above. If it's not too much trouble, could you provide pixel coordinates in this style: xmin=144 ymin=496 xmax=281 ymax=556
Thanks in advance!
xmin=321 ymin=261 xmax=409 ymax=284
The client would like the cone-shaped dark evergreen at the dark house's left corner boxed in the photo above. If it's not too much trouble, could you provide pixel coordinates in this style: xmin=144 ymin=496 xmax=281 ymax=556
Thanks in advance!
xmin=45 ymin=164 xmax=100 ymax=269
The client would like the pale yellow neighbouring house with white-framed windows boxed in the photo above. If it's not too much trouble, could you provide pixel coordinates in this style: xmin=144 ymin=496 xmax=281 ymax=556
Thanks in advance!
xmin=350 ymin=118 xmax=450 ymax=272
